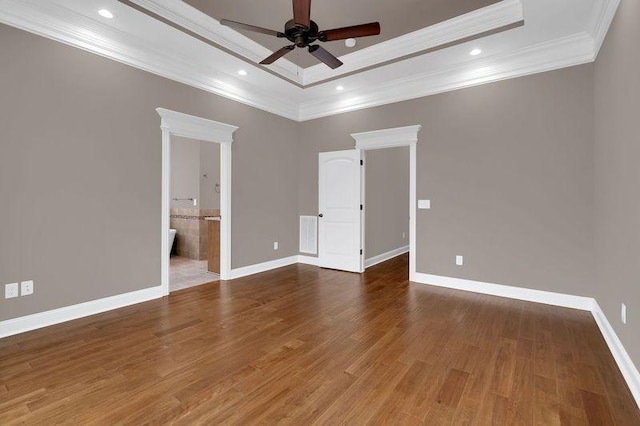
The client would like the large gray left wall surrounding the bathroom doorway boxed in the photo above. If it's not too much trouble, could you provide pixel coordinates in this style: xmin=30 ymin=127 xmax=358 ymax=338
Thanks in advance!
xmin=0 ymin=25 xmax=298 ymax=320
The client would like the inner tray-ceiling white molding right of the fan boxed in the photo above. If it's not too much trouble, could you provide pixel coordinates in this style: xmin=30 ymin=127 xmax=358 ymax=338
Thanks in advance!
xmin=302 ymin=0 xmax=524 ymax=86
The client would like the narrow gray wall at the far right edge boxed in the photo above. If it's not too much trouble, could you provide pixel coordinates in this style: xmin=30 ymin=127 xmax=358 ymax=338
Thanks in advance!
xmin=595 ymin=0 xmax=640 ymax=367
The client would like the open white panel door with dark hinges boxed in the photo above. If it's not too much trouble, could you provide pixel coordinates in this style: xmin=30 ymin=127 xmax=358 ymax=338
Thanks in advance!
xmin=318 ymin=149 xmax=364 ymax=272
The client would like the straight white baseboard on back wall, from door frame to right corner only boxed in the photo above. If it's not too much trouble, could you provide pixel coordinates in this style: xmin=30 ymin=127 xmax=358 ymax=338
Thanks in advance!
xmin=414 ymin=272 xmax=593 ymax=311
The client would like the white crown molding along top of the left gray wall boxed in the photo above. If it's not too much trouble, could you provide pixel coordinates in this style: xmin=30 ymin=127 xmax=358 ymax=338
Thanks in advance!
xmin=0 ymin=0 xmax=298 ymax=120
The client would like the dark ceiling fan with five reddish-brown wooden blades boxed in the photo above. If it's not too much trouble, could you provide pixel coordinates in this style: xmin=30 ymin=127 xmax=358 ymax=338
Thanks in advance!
xmin=220 ymin=0 xmax=380 ymax=69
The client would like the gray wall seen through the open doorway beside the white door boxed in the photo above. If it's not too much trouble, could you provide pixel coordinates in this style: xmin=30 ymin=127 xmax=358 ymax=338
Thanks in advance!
xmin=365 ymin=147 xmax=409 ymax=259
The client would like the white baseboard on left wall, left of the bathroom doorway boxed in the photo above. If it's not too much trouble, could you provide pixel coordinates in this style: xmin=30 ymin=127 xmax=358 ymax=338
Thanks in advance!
xmin=0 ymin=286 xmax=162 ymax=338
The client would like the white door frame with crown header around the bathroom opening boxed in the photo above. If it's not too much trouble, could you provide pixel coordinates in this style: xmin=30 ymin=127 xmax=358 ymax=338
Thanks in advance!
xmin=156 ymin=108 xmax=238 ymax=296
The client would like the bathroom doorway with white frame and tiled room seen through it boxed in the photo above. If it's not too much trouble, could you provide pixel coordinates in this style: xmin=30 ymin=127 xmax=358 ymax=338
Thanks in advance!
xmin=157 ymin=108 xmax=238 ymax=295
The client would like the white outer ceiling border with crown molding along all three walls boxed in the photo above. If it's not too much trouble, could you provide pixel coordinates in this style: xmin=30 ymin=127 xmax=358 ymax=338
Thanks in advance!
xmin=0 ymin=0 xmax=619 ymax=121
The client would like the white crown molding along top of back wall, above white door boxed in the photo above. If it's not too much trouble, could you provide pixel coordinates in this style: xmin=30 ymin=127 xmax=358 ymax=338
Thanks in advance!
xmin=299 ymin=32 xmax=594 ymax=121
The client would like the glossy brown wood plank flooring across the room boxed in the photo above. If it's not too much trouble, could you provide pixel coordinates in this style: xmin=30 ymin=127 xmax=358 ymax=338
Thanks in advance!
xmin=0 ymin=256 xmax=640 ymax=425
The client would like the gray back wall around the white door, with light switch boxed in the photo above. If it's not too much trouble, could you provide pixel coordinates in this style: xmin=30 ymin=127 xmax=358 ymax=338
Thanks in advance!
xmin=299 ymin=65 xmax=595 ymax=296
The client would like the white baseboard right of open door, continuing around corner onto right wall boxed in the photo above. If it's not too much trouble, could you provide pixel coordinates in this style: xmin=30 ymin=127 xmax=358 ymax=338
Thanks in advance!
xmin=413 ymin=272 xmax=640 ymax=407
